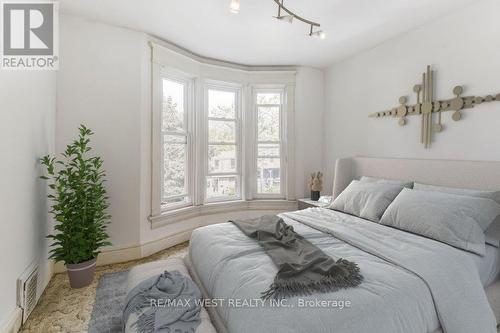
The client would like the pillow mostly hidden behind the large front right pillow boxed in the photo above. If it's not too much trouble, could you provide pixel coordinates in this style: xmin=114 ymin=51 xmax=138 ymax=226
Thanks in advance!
xmin=413 ymin=183 xmax=500 ymax=247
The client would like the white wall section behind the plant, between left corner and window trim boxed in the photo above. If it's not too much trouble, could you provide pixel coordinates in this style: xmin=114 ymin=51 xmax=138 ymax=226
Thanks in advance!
xmin=57 ymin=15 xmax=147 ymax=245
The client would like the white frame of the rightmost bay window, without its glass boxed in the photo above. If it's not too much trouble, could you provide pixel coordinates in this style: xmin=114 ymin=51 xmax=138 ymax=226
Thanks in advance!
xmin=251 ymin=85 xmax=288 ymax=199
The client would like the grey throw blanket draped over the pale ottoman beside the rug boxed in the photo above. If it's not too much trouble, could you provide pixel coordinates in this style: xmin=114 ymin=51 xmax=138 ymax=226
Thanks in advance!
xmin=123 ymin=271 xmax=201 ymax=333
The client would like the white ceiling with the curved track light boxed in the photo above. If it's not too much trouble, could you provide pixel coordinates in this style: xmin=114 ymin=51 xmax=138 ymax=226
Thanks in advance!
xmin=60 ymin=0 xmax=476 ymax=68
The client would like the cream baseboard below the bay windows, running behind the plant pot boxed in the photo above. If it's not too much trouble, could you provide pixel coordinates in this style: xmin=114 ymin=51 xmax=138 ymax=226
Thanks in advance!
xmin=54 ymin=229 xmax=192 ymax=273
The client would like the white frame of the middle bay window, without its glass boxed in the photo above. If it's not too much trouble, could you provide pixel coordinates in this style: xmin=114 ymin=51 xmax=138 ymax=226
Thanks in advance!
xmin=200 ymin=80 xmax=244 ymax=204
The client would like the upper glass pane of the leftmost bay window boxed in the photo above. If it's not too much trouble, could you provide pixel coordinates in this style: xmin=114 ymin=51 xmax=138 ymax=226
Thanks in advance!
xmin=162 ymin=79 xmax=185 ymax=131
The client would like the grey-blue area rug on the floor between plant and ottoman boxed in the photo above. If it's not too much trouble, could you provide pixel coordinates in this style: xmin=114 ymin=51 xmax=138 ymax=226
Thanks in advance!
xmin=88 ymin=270 xmax=129 ymax=333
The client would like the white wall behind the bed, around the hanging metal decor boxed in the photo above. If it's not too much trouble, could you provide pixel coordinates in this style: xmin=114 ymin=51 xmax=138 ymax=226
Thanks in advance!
xmin=324 ymin=0 xmax=500 ymax=191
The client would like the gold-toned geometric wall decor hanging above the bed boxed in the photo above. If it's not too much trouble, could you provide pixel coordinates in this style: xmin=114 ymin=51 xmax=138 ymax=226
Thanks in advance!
xmin=369 ymin=66 xmax=500 ymax=148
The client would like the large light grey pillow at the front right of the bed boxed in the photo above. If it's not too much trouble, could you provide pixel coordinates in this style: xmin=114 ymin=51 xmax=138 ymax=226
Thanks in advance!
xmin=380 ymin=189 xmax=500 ymax=255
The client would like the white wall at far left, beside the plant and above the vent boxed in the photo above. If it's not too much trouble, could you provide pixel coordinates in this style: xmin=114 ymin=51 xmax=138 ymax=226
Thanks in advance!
xmin=0 ymin=71 xmax=56 ymax=328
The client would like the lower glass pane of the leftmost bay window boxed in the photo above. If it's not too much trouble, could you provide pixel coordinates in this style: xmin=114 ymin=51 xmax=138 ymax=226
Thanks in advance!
xmin=163 ymin=135 xmax=187 ymax=198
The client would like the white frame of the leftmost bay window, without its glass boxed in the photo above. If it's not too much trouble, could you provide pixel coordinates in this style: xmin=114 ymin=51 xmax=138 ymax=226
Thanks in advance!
xmin=152 ymin=67 xmax=196 ymax=214
